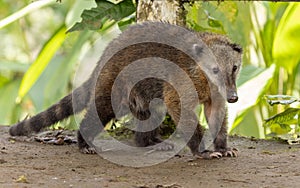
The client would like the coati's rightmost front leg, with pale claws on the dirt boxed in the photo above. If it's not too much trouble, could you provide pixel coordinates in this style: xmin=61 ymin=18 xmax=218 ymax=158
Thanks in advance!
xmin=204 ymin=96 xmax=238 ymax=157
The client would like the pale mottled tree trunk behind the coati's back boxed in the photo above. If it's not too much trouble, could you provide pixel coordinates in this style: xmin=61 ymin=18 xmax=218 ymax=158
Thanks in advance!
xmin=136 ymin=0 xmax=185 ymax=26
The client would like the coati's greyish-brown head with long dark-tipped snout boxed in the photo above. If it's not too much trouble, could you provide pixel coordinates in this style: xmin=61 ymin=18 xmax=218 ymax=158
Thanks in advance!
xmin=200 ymin=33 xmax=243 ymax=103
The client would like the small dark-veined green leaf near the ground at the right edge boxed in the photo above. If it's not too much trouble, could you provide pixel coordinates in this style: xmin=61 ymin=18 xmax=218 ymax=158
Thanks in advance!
xmin=265 ymin=108 xmax=300 ymax=126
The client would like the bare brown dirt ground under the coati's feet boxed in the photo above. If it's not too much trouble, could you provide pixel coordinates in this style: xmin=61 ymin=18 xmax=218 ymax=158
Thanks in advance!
xmin=0 ymin=126 xmax=300 ymax=188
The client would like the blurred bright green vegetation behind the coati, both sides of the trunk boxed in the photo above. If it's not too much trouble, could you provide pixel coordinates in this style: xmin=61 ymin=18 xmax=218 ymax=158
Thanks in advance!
xmin=0 ymin=0 xmax=300 ymax=141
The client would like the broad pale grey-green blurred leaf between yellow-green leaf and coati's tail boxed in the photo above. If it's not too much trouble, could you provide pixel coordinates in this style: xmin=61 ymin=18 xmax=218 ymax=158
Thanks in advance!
xmin=28 ymin=31 xmax=93 ymax=112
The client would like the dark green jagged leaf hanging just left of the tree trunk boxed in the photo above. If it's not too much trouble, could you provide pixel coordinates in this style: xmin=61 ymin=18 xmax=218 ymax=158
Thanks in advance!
xmin=68 ymin=0 xmax=136 ymax=32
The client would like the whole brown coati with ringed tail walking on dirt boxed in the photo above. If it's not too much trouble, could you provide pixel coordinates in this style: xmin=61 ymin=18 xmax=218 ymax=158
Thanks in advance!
xmin=9 ymin=22 xmax=242 ymax=158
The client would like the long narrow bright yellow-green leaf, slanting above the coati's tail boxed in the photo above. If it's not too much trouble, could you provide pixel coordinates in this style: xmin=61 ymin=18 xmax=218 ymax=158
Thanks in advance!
xmin=17 ymin=26 xmax=66 ymax=102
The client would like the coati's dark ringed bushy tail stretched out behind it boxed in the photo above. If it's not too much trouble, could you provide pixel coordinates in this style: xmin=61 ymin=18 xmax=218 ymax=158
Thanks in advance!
xmin=9 ymin=82 xmax=90 ymax=136
